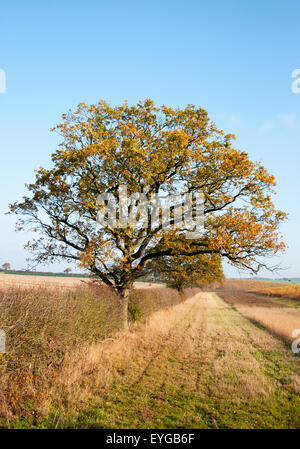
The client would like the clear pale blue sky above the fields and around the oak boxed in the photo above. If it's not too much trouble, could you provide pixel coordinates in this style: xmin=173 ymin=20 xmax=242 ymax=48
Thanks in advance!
xmin=0 ymin=0 xmax=300 ymax=276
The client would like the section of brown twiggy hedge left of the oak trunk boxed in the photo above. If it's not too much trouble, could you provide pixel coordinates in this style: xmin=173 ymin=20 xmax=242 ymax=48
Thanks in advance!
xmin=0 ymin=289 xmax=118 ymax=421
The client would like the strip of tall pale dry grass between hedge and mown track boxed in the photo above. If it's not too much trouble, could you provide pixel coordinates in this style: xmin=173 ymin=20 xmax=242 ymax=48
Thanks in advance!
xmin=51 ymin=299 xmax=198 ymax=415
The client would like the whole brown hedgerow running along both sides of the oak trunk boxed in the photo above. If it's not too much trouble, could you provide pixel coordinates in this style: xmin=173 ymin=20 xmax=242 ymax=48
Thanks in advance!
xmin=0 ymin=285 xmax=188 ymax=426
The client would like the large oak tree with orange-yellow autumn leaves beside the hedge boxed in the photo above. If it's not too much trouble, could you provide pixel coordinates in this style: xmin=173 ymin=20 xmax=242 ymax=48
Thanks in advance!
xmin=11 ymin=100 xmax=285 ymax=321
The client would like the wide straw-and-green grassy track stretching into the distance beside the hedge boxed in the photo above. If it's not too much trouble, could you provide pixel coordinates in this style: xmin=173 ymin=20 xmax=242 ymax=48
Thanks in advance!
xmin=70 ymin=293 xmax=300 ymax=428
